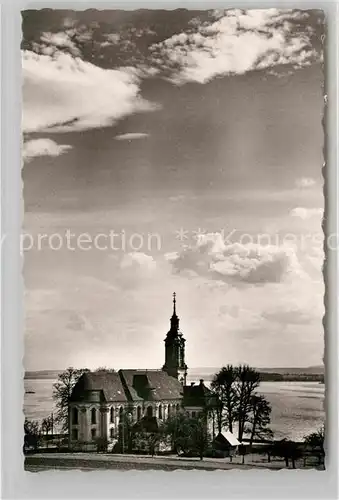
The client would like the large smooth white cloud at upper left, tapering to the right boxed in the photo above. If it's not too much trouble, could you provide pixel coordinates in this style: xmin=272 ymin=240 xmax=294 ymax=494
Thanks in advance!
xmin=22 ymin=51 xmax=157 ymax=132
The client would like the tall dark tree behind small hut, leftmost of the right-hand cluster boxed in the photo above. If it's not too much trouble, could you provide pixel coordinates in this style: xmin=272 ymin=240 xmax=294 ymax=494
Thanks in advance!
xmin=211 ymin=365 xmax=238 ymax=433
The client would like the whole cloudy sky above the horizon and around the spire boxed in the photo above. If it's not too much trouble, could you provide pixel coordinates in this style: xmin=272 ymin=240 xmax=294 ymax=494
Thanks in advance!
xmin=22 ymin=9 xmax=324 ymax=370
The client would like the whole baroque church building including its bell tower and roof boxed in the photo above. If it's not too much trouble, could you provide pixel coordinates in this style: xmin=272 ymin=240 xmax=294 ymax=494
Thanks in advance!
xmin=69 ymin=294 xmax=218 ymax=452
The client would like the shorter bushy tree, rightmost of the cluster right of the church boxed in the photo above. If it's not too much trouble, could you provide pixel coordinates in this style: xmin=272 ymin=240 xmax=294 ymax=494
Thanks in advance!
xmin=248 ymin=394 xmax=273 ymax=446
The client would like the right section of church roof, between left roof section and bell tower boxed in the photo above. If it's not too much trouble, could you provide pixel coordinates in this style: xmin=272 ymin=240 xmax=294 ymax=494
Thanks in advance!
xmin=119 ymin=370 xmax=183 ymax=401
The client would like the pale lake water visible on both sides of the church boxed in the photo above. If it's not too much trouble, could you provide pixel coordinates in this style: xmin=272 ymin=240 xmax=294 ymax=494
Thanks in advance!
xmin=24 ymin=379 xmax=325 ymax=440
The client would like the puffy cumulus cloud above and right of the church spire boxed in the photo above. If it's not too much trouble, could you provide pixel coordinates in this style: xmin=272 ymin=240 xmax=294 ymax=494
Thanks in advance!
xmin=167 ymin=233 xmax=302 ymax=284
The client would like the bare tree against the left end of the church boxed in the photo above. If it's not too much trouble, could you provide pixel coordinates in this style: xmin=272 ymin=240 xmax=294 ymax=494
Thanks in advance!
xmin=53 ymin=367 xmax=89 ymax=432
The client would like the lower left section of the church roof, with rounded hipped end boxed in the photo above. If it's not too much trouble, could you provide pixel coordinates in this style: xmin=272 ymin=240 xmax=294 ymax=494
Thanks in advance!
xmin=71 ymin=372 xmax=127 ymax=403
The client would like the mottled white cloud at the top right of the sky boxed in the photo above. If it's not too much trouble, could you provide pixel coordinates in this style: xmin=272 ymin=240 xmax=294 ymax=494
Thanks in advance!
xmin=150 ymin=9 xmax=321 ymax=84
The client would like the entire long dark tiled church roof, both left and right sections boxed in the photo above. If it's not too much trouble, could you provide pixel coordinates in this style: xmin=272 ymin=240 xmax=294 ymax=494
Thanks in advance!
xmin=71 ymin=370 xmax=183 ymax=403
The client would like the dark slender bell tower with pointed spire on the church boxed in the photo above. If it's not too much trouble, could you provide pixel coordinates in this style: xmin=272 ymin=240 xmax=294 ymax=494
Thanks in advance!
xmin=162 ymin=293 xmax=187 ymax=385
